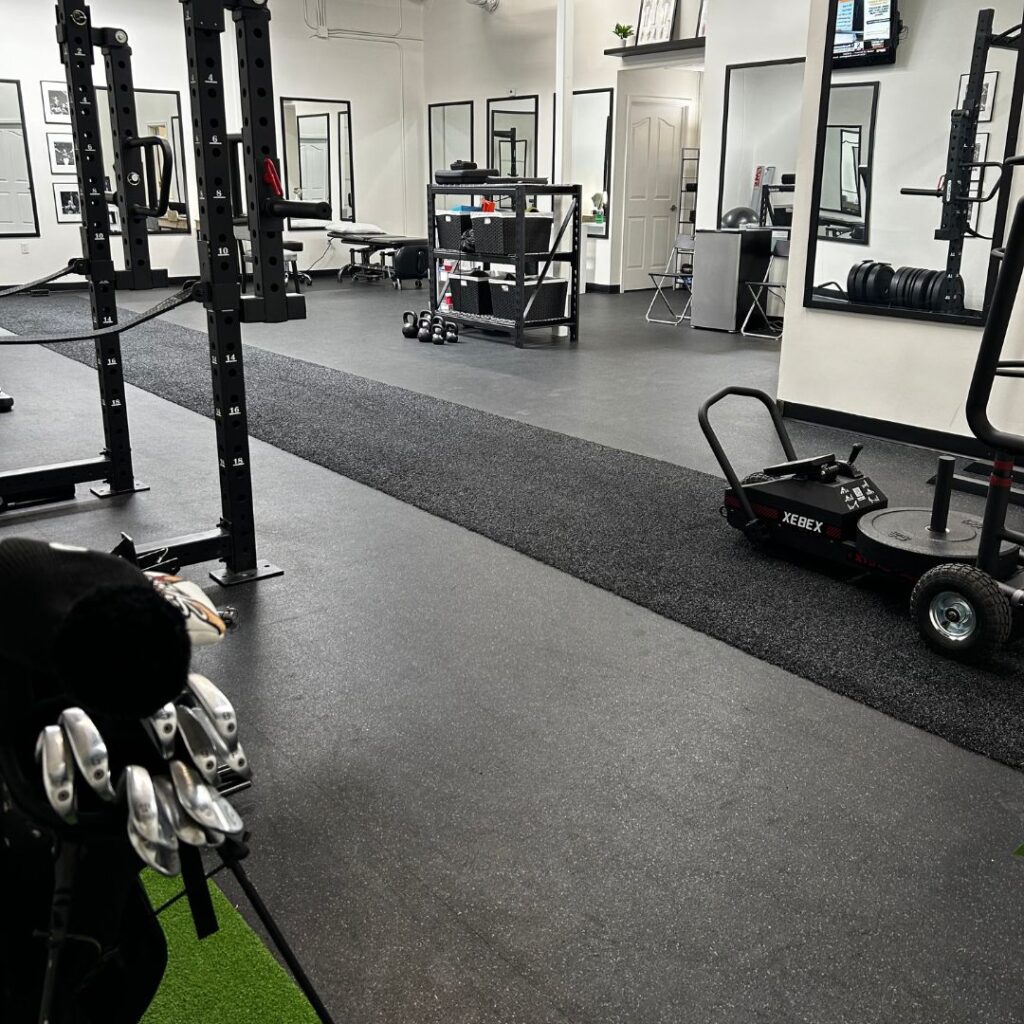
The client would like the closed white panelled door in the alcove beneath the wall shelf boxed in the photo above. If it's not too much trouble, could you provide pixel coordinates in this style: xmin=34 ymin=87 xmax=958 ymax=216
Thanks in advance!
xmin=623 ymin=100 xmax=686 ymax=292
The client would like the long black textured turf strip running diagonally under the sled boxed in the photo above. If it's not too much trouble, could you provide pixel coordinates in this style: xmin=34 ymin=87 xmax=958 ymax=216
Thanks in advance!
xmin=6 ymin=294 xmax=1024 ymax=767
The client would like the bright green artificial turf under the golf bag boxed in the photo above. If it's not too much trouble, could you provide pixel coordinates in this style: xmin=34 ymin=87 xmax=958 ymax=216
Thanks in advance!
xmin=142 ymin=870 xmax=317 ymax=1024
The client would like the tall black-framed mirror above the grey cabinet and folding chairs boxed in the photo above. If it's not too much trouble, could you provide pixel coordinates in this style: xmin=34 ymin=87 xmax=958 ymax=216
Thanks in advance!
xmin=718 ymin=57 xmax=804 ymax=227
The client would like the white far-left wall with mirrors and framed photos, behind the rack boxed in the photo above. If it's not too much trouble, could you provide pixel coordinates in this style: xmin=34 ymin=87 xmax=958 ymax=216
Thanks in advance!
xmin=0 ymin=0 xmax=426 ymax=282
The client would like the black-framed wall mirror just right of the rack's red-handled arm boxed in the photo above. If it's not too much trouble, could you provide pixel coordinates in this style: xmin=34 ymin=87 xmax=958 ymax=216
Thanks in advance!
xmin=281 ymin=96 xmax=355 ymax=231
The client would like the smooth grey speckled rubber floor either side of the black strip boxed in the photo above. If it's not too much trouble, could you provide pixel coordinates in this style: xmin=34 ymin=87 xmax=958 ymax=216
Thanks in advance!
xmin=0 ymin=288 xmax=1024 ymax=1024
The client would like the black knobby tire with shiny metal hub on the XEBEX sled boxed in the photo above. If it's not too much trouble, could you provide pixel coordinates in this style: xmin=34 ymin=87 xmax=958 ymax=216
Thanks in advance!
xmin=910 ymin=564 xmax=1013 ymax=660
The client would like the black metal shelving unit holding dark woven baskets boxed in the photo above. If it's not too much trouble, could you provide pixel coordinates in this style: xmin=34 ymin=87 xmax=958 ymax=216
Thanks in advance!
xmin=427 ymin=184 xmax=583 ymax=348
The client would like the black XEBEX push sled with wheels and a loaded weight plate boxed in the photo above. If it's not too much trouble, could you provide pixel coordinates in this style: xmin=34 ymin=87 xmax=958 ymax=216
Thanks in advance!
xmin=698 ymin=200 xmax=1024 ymax=657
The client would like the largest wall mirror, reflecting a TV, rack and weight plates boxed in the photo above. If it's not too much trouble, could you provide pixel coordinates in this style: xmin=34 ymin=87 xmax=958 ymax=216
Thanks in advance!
xmin=805 ymin=0 xmax=1024 ymax=326
